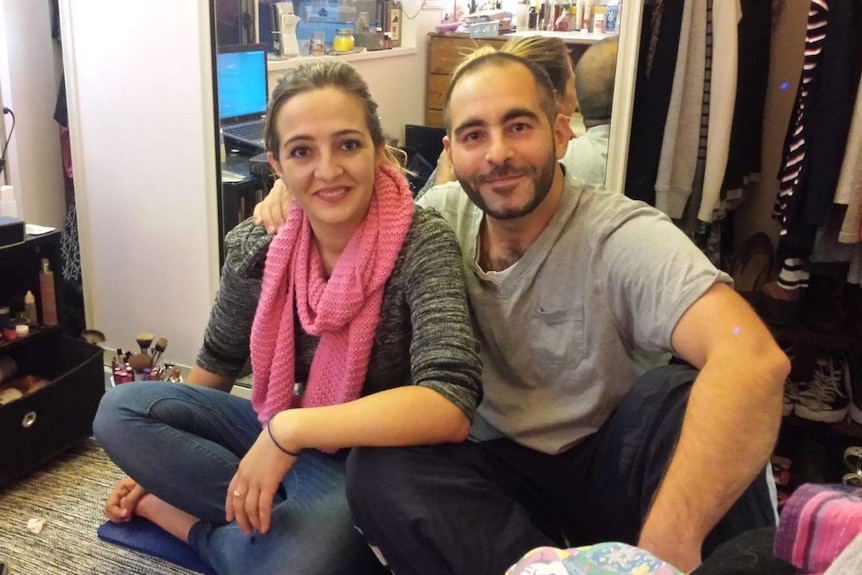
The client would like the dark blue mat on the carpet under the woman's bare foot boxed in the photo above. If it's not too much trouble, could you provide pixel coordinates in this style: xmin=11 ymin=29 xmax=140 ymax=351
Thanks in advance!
xmin=96 ymin=517 xmax=216 ymax=575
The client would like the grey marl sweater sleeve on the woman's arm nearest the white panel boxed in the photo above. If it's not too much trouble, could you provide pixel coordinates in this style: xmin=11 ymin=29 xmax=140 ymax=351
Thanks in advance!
xmin=196 ymin=218 xmax=272 ymax=378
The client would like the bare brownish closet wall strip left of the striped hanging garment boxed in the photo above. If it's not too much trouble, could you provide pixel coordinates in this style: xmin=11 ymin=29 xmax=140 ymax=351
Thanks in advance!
xmin=735 ymin=0 xmax=809 ymax=250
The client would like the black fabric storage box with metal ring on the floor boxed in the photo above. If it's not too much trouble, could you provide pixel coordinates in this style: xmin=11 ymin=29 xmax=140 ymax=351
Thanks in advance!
xmin=0 ymin=329 xmax=105 ymax=485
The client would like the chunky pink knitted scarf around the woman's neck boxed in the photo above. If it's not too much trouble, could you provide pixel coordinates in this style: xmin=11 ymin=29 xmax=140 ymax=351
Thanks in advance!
xmin=251 ymin=165 xmax=413 ymax=424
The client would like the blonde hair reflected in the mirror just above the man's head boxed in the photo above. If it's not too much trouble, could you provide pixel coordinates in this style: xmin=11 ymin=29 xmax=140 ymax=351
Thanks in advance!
xmin=452 ymin=36 xmax=572 ymax=104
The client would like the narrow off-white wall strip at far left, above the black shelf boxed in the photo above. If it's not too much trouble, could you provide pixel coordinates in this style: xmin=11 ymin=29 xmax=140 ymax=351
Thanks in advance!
xmin=0 ymin=0 xmax=65 ymax=227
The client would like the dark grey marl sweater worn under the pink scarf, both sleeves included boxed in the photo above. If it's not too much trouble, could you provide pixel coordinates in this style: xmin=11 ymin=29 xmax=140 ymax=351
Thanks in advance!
xmin=197 ymin=206 xmax=482 ymax=420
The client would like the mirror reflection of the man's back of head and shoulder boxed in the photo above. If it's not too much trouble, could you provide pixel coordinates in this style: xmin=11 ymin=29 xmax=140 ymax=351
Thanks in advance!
xmin=561 ymin=36 xmax=619 ymax=185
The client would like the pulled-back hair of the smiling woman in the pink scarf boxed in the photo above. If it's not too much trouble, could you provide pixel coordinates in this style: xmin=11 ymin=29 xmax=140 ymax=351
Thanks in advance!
xmin=264 ymin=60 xmax=403 ymax=169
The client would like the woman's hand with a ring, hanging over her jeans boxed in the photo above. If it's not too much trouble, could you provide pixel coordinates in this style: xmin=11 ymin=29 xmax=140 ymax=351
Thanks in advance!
xmin=225 ymin=429 xmax=296 ymax=535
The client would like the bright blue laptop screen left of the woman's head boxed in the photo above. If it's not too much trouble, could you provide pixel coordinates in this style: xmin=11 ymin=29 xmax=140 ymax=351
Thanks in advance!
xmin=217 ymin=51 xmax=267 ymax=120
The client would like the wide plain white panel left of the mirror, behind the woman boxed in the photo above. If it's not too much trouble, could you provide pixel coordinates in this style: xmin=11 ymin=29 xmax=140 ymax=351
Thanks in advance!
xmin=59 ymin=0 xmax=218 ymax=364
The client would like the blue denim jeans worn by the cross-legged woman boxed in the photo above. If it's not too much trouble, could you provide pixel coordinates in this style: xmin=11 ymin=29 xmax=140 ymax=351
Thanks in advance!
xmin=93 ymin=382 xmax=380 ymax=574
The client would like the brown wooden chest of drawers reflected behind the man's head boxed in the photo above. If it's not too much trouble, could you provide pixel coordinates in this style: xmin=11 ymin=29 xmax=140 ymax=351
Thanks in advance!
xmin=425 ymin=32 xmax=602 ymax=127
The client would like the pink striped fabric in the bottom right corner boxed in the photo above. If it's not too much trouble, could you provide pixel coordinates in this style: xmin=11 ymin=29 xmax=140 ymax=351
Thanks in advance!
xmin=775 ymin=483 xmax=862 ymax=574
